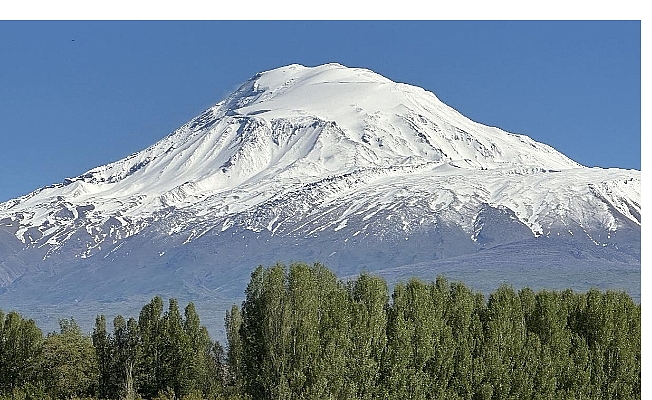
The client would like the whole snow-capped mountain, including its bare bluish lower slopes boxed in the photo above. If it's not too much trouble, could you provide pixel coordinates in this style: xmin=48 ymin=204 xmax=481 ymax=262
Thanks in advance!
xmin=0 ymin=64 xmax=641 ymax=338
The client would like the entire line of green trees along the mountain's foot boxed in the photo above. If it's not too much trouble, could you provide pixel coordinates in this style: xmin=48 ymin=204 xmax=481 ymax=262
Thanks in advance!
xmin=0 ymin=263 xmax=641 ymax=400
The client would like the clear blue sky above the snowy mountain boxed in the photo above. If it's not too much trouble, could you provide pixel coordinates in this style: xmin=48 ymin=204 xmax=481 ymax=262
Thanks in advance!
xmin=0 ymin=21 xmax=641 ymax=201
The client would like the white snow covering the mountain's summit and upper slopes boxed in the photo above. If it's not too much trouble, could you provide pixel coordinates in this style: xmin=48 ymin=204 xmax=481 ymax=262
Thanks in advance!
xmin=0 ymin=64 xmax=641 ymax=256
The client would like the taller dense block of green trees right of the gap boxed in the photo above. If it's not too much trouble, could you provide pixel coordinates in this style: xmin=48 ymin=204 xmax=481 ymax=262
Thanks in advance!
xmin=232 ymin=263 xmax=641 ymax=399
